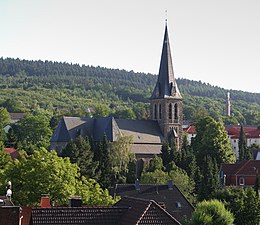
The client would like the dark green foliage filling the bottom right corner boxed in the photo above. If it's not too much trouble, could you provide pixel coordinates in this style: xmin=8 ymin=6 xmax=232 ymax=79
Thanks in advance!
xmin=215 ymin=187 xmax=260 ymax=225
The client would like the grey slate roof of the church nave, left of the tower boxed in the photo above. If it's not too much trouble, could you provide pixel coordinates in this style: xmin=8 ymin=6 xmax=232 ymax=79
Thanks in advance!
xmin=51 ymin=117 xmax=163 ymax=155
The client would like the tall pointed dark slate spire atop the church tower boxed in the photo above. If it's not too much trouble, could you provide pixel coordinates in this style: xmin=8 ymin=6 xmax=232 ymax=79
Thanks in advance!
xmin=151 ymin=21 xmax=182 ymax=99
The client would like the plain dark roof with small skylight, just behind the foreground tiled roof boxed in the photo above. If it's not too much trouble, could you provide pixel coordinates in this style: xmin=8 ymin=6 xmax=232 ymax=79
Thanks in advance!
xmin=111 ymin=184 xmax=194 ymax=220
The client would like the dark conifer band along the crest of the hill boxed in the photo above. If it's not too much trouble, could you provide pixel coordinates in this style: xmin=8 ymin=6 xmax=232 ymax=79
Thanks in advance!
xmin=0 ymin=58 xmax=260 ymax=104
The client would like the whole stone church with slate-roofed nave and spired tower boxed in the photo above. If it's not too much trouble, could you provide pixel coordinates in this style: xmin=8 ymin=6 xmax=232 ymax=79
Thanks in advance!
xmin=50 ymin=21 xmax=183 ymax=161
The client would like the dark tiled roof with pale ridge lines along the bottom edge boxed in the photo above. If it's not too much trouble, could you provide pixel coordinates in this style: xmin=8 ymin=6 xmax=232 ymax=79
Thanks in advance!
xmin=27 ymin=198 xmax=181 ymax=225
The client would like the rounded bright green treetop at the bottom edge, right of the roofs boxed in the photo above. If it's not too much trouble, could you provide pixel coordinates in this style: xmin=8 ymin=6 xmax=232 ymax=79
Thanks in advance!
xmin=189 ymin=200 xmax=234 ymax=225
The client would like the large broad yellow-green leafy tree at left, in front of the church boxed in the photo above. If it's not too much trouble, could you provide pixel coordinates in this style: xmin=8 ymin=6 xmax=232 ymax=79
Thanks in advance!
xmin=0 ymin=148 xmax=116 ymax=206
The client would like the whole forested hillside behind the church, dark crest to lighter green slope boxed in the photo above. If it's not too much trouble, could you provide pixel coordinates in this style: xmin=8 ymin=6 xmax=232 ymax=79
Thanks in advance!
xmin=0 ymin=58 xmax=260 ymax=123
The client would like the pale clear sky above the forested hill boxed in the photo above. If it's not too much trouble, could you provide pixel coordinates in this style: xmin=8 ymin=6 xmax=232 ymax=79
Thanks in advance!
xmin=0 ymin=0 xmax=260 ymax=93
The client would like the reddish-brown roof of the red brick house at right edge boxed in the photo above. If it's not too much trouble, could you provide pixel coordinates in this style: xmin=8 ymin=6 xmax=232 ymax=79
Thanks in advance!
xmin=221 ymin=160 xmax=260 ymax=176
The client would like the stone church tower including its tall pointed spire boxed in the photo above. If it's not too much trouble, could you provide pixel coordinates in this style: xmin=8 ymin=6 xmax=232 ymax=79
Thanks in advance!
xmin=150 ymin=21 xmax=183 ymax=149
